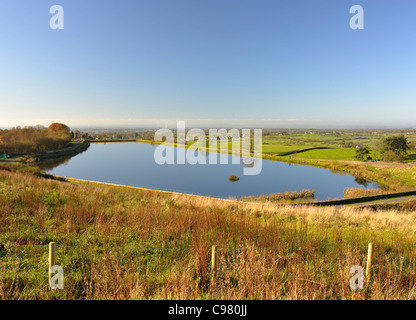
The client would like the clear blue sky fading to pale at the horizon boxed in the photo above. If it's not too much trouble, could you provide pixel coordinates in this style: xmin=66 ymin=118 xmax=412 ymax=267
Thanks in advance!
xmin=0 ymin=0 xmax=416 ymax=128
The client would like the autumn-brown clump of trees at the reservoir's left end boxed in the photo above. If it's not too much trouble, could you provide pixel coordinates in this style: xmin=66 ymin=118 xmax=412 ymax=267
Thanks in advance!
xmin=0 ymin=123 xmax=72 ymax=154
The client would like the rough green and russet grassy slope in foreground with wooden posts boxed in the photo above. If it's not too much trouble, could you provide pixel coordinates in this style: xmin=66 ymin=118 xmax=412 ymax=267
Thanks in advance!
xmin=0 ymin=171 xmax=416 ymax=299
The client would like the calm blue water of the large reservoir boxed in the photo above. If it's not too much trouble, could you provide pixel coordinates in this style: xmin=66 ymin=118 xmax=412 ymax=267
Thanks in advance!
xmin=40 ymin=142 xmax=378 ymax=200
